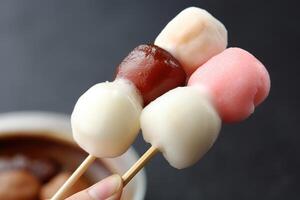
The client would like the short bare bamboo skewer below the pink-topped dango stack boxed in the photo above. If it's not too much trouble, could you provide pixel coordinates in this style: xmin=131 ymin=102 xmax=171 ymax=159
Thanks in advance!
xmin=122 ymin=146 xmax=158 ymax=186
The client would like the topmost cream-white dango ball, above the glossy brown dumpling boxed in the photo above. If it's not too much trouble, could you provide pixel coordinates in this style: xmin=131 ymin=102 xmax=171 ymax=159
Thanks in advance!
xmin=154 ymin=7 xmax=227 ymax=75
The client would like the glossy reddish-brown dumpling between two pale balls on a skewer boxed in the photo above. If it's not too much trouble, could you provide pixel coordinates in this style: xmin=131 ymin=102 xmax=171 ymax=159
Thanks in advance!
xmin=116 ymin=45 xmax=186 ymax=106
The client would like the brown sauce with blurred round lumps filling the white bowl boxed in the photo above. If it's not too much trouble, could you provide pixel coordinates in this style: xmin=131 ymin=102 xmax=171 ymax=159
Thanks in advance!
xmin=0 ymin=132 xmax=111 ymax=200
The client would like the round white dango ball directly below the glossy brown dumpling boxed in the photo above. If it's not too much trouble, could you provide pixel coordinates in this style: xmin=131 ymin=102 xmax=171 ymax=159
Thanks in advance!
xmin=71 ymin=79 xmax=142 ymax=157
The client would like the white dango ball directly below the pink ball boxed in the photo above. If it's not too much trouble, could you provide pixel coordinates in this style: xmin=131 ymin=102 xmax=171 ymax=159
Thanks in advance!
xmin=141 ymin=87 xmax=221 ymax=169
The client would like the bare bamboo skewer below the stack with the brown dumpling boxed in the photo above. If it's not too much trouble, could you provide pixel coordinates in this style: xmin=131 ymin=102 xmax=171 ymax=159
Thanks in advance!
xmin=51 ymin=155 xmax=96 ymax=200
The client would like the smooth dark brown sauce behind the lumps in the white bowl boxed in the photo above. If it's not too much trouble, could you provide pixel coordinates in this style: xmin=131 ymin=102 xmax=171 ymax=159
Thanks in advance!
xmin=0 ymin=132 xmax=111 ymax=183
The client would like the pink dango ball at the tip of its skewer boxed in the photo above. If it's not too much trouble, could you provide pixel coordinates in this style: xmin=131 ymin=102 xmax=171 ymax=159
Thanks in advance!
xmin=188 ymin=48 xmax=270 ymax=123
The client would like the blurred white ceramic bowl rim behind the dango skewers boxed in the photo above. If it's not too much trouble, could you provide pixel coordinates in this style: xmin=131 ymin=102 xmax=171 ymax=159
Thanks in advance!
xmin=0 ymin=111 xmax=146 ymax=200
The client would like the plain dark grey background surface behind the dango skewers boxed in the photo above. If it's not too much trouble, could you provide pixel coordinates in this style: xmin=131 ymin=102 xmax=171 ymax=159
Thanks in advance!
xmin=0 ymin=0 xmax=300 ymax=200
